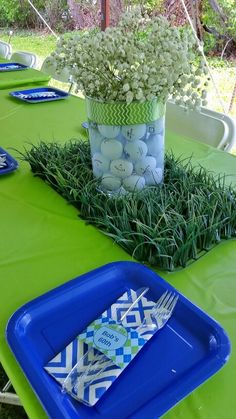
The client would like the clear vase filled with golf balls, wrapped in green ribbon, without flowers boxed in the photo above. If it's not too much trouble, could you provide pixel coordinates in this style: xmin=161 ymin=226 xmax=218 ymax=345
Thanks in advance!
xmin=86 ymin=98 xmax=165 ymax=193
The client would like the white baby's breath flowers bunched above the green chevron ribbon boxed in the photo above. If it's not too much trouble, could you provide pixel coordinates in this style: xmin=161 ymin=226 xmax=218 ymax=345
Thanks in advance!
xmin=51 ymin=11 xmax=206 ymax=109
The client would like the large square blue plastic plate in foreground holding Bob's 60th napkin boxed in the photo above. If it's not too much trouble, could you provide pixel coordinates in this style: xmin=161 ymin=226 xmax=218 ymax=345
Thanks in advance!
xmin=6 ymin=262 xmax=230 ymax=419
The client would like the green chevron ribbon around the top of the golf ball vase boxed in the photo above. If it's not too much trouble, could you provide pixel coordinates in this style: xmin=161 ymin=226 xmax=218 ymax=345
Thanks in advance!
xmin=86 ymin=98 xmax=165 ymax=125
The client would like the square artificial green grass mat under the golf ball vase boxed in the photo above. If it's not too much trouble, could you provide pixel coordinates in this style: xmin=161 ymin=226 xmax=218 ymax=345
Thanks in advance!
xmin=22 ymin=140 xmax=236 ymax=271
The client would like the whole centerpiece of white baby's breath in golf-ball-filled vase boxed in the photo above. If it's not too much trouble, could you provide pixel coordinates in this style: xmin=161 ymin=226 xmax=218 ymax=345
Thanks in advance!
xmin=48 ymin=11 xmax=206 ymax=193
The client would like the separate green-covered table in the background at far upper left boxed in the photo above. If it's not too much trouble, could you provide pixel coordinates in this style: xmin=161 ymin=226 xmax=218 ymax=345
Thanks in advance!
xmin=0 ymin=58 xmax=51 ymax=90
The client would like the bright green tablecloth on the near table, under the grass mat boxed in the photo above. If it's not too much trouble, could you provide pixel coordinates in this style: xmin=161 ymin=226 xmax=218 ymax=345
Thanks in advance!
xmin=0 ymin=86 xmax=236 ymax=419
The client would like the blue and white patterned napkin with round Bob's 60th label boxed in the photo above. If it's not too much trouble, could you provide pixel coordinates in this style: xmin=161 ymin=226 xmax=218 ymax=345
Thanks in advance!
xmin=44 ymin=289 xmax=158 ymax=406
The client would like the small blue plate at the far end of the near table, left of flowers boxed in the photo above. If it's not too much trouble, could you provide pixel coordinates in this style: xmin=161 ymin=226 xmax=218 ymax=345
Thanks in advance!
xmin=9 ymin=87 xmax=69 ymax=103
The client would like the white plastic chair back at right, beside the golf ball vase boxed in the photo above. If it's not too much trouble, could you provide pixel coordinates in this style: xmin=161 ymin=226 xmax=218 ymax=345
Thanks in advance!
xmin=166 ymin=101 xmax=236 ymax=152
